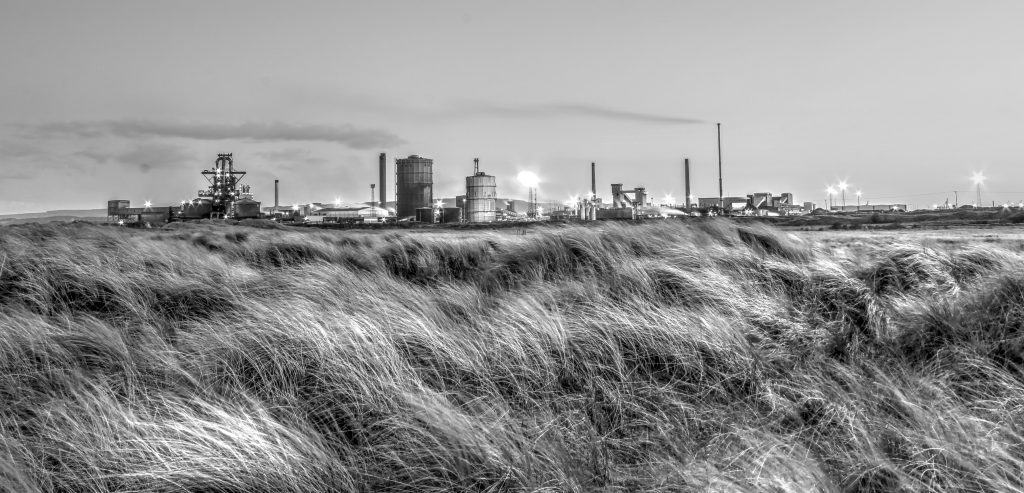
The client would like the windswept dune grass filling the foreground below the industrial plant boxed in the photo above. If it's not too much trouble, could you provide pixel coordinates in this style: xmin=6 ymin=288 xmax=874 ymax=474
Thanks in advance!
xmin=0 ymin=221 xmax=1024 ymax=492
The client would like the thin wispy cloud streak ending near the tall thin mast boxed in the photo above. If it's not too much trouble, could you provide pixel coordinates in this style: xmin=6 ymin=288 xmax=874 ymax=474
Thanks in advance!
xmin=454 ymin=101 xmax=705 ymax=125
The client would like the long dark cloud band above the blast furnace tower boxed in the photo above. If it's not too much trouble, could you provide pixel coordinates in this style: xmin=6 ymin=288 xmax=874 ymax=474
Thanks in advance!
xmin=25 ymin=120 xmax=403 ymax=150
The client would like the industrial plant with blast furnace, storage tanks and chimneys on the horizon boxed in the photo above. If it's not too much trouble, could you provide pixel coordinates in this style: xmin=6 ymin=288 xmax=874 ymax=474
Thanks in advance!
xmin=108 ymin=146 xmax=905 ymax=225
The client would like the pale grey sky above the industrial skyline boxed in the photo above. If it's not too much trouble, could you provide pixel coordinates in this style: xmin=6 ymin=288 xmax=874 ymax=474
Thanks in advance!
xmin=0 ymin=0 xmax=1024 ymax=213
